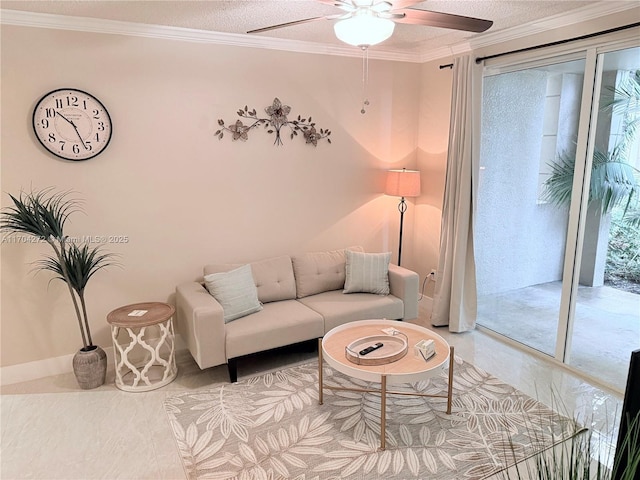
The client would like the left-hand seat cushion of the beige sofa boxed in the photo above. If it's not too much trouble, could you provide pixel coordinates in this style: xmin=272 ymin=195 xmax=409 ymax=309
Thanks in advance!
xmin=226 ymin=300 xmax=324 ymax=359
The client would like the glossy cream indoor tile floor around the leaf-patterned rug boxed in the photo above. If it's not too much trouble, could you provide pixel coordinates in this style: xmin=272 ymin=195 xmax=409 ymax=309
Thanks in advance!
xmin=0 ymin=310 xmax=622 ymax=480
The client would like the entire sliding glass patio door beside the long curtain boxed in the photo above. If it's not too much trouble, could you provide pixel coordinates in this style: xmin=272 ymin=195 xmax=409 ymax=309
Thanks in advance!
xmin=474 ymin=43 xmax=640 ymax=389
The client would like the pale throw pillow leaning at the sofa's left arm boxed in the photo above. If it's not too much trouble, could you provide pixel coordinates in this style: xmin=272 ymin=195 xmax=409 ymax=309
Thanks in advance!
xmin=204 ymin=265 xmax=262 ymax=323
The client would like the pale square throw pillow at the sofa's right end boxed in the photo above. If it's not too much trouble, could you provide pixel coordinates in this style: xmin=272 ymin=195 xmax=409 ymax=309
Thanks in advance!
xmin=344 ymin=250 xmax=391 ymax=295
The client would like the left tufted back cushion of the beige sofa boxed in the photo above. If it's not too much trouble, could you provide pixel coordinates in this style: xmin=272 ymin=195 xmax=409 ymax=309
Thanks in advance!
xmin=204 ymin=255 xmax=296 ymax=303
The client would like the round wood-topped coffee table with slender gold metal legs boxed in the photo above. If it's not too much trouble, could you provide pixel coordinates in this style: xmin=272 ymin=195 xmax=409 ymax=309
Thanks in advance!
xmin=318 ymin=320 xmax=454 ymax=450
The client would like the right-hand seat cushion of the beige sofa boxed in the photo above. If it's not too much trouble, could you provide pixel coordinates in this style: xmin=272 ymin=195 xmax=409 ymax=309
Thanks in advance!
xmin=298 ymin=290 xmax=404 ymax=333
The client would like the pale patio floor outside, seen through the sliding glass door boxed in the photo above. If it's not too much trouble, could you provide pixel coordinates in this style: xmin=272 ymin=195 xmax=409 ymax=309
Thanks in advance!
xmin=478 ymin=282 xmax=640 ymax=392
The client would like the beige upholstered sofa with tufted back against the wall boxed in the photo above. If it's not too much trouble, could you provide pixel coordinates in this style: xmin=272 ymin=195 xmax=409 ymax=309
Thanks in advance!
xmin=176 ymin=247 xmax=419 ymax=382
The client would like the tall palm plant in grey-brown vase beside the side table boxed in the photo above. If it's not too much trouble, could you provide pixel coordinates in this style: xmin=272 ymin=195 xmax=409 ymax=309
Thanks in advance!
xmin=0 ymin=188 xmax=114 ymax=389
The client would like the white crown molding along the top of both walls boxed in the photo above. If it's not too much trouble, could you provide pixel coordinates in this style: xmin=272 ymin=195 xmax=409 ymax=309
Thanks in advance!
xmin=0 ymin=1 xmax=638 ymax=63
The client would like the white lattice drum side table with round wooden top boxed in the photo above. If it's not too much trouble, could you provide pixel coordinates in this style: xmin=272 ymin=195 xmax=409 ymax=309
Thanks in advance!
xmin=107 ymin=302 xmax=178 ymax=392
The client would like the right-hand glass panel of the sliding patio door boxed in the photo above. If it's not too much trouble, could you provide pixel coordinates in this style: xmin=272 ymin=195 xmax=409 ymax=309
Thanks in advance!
xmin=565 ymin=48 xmax=640 ymax=389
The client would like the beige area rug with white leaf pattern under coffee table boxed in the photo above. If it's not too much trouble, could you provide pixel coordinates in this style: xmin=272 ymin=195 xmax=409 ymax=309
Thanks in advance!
xmin=165 ymin=358 xmax=580 ymax=480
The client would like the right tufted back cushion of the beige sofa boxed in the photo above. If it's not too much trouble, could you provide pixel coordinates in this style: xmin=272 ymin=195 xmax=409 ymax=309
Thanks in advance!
xmin=291 ymin=247 xmax=364 ymax=298
